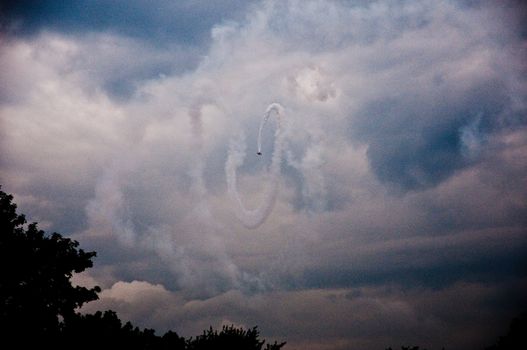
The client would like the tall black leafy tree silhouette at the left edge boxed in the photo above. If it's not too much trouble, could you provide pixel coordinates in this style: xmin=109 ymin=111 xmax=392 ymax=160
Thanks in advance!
xmin=0 ymin=187 xmax=100 ymax=341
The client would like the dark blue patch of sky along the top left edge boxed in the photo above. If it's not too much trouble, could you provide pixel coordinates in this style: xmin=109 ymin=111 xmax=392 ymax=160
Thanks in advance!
xmin=0 ymin=0 xmax=256 ymax=46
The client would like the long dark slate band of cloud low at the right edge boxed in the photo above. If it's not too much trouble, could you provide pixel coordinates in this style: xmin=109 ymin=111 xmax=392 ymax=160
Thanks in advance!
xmin=301 ymin=232 xmax=527 ymax=289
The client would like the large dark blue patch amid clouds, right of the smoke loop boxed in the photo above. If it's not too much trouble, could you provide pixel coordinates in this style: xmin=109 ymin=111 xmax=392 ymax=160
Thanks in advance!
xmin=353 ymin=80 xmax=524 ymax=190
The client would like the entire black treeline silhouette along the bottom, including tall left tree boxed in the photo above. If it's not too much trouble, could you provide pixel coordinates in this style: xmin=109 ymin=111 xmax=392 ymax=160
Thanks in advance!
xmin=0 ymin=185 xmax=527 ymax=350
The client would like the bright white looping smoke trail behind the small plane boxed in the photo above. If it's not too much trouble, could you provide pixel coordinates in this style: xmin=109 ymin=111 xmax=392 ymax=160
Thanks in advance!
xmin=225 ymin=103 xmax=284 ymax=228
